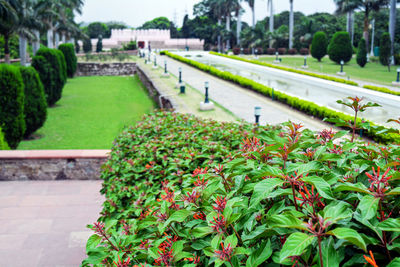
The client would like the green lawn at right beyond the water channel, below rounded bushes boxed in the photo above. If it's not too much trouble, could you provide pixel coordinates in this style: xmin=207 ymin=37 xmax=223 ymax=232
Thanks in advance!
xmin=255 ymin=55 xmax=397 ymax=86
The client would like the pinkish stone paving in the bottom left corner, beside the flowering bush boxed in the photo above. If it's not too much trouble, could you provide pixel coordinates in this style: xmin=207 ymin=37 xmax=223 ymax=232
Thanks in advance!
xmin=0 ymin=181 xmax=104 ymax=267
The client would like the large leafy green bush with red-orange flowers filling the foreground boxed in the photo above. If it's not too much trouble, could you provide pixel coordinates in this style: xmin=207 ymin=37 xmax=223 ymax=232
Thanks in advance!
xmin=82 ymin=112 xmax=400 ymax=267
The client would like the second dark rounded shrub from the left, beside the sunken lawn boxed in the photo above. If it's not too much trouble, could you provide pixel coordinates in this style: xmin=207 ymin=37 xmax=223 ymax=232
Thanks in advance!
xmin=20 ymin=67 xmax=47 ymax=137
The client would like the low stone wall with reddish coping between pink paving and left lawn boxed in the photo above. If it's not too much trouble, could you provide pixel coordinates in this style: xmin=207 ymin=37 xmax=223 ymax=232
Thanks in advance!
xmin=0 ymin=150 xmax=109 ymax=181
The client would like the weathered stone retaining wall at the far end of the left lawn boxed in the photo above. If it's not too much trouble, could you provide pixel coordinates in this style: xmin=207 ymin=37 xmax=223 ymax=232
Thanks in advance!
xmin=75 ymin=62 xmax=136 ymax=76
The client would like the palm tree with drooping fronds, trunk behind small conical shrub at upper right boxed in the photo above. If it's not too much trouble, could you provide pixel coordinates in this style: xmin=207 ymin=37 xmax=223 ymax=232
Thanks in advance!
xmin=334 ymin=0 xmax=390 ymax=51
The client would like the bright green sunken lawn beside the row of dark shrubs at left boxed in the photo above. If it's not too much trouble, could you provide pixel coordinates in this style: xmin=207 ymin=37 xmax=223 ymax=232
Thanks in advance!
xmin=18 ymin=76 xmax=154 ymax=149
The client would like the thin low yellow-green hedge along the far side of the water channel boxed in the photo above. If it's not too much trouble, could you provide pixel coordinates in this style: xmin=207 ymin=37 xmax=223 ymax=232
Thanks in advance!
xmin=210 ymin=52 xmax=358 ymax=86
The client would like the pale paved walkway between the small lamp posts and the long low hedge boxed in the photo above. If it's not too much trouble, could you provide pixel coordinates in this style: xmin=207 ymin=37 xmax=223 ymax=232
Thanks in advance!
xmin=158 ymin=56 xmax=332 ymax=131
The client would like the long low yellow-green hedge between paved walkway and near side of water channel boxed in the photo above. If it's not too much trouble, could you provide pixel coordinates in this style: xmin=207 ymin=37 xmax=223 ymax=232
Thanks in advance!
xmin=165 ymin=51 xmax=400 ymax=146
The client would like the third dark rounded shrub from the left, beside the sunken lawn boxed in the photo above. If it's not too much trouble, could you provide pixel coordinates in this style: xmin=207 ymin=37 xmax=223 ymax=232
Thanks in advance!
xmin=32 ymin=48 xmax=66 ymax=106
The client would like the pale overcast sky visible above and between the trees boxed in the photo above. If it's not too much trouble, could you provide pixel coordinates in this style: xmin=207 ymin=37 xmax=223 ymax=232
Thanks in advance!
xmin=76 ymin=0 xmax=335 ymax=27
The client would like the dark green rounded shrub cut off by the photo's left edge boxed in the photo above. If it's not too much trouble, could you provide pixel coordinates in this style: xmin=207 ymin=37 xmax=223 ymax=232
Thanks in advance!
xmin=0 ymin=64 xmax=26 ymax=149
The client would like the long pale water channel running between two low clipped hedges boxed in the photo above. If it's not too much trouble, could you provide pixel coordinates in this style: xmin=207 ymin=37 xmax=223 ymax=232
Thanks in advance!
xmin=174 ymin=51 xmax=400 ymax=128
